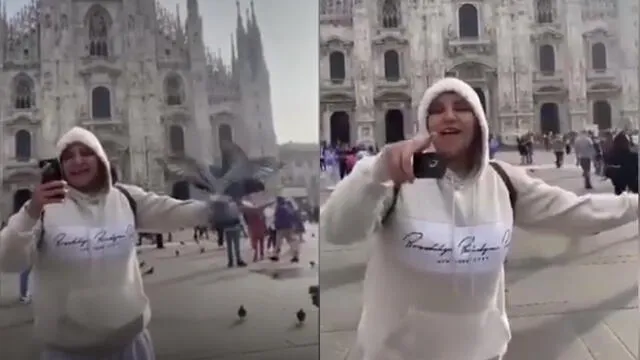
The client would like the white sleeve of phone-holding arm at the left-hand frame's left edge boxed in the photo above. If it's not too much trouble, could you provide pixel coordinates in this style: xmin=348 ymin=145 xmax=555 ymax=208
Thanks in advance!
xmin=0 ymin=202 xmax=41 ymax=273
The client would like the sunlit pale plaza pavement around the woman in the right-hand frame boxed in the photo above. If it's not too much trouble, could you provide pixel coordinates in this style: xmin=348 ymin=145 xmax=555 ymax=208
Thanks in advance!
xmin=320 ymin=151 xmax=639 ymax=360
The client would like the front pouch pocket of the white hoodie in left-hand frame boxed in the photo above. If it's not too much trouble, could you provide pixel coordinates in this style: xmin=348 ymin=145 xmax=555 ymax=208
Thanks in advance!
xmin=66 ymin=287 xmax=149 ymax=335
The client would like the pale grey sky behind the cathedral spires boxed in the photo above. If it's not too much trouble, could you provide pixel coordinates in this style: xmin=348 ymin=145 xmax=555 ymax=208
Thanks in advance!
xmin=7 ymin=0 xmax=319 ymax=143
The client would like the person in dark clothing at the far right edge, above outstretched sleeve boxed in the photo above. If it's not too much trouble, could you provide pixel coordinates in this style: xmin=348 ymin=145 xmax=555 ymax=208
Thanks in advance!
xmin=605 ymin=133 xmax=638 ymax=195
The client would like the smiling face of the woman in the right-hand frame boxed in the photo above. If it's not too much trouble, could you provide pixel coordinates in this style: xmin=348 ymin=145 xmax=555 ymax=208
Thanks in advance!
xmin=427 ymin=92 xmax=477 ymax=159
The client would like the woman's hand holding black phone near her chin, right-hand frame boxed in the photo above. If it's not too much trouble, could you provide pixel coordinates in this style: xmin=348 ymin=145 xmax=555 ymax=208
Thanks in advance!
xmin=382 ymin=134 xmax=434 ymax=185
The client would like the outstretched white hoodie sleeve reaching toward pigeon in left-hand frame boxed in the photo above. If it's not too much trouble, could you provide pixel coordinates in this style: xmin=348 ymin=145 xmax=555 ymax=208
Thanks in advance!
xmin=120 ymin=184 xmax=211 ymax=232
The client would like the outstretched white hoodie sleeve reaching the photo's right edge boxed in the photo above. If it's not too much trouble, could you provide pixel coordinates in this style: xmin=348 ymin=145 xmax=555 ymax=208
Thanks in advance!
xmin=500 ymin=162 xmax=638 ymax=236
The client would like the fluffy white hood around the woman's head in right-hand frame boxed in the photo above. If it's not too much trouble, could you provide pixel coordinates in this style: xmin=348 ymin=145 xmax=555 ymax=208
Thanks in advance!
xmin=417 ymin=77 xmax=489 ymax=178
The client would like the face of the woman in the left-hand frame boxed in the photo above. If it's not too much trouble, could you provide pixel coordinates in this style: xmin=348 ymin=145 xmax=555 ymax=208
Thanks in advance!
xmin=60 ymin=143 xmax=100 ymax=190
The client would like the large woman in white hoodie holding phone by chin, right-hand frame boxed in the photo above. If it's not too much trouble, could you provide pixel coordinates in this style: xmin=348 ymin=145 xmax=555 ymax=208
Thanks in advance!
xmin=320 ymin=78 xmax=638 ymax=360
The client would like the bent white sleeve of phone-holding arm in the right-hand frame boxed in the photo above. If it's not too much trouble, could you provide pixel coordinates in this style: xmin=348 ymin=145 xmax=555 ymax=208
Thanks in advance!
xmin=320 ymin=153 xmax=393 ymax=245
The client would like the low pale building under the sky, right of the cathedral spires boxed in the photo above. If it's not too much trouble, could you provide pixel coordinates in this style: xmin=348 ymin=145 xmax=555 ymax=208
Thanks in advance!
xmin=279 ymin=143 xmax=320 ymax=206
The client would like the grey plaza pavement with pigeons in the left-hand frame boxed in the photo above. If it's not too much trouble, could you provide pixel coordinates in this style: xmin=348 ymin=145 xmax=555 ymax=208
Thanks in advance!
xmin=0 ymin=225 xmax=319 ymax=360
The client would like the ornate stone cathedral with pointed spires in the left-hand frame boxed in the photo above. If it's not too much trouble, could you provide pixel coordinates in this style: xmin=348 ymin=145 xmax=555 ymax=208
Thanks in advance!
xmin=0 ymin=0 xmax=278 ymax=219
